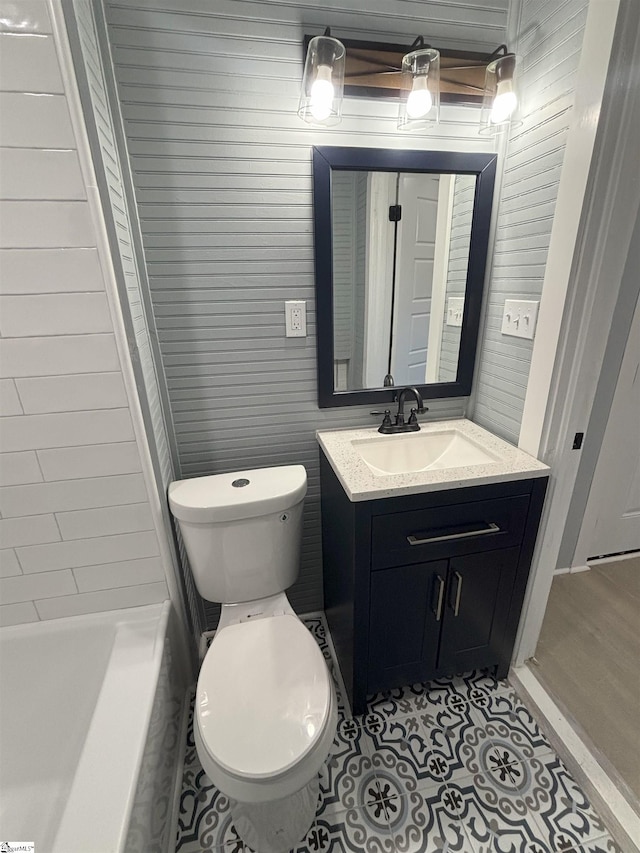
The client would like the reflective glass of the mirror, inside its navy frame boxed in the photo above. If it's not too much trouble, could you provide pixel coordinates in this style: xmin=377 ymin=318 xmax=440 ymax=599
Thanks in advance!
xmin=331 ymin=170 xmax=476 ymax=391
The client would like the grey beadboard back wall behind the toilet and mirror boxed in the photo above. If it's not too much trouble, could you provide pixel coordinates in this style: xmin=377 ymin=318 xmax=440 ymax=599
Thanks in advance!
xmin=105 ymin=0 xmax=507 ymax=610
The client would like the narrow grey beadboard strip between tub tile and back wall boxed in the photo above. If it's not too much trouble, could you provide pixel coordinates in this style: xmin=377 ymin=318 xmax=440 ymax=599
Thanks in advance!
xmin=67 ymin=0 xmax=203 ymax=633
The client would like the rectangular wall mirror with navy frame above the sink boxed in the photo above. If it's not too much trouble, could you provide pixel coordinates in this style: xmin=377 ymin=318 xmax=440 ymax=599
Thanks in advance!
xmin=313 ymin=147 xmax=496 ymax=407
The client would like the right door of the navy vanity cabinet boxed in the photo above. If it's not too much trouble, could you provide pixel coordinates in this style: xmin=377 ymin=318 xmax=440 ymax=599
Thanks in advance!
xmin=438 ymin=548 xmax=520 ymax=672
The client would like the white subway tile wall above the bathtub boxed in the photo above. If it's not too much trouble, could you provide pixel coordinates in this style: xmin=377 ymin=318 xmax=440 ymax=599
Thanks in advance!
xmin=0 ymin=0 xmax=168 ymax=625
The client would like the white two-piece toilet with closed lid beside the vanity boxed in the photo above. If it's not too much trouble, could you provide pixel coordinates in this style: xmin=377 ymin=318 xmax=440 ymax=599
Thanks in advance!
xmin=169 ymin=465 xmax=337 ymax=853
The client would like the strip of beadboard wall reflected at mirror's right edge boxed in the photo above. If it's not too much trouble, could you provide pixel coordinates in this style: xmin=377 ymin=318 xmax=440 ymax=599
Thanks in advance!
xmin=438 ymin=175 xmax=476 ymax=382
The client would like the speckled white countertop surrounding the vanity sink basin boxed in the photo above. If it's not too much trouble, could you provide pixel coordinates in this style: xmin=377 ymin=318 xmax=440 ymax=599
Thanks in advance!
xmin=316 ymin=419 xmax=550 ymax=501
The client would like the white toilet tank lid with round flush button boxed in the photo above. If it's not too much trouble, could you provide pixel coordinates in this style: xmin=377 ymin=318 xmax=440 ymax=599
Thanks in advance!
xmin=169 ymin=465 xmax=307 ymax=524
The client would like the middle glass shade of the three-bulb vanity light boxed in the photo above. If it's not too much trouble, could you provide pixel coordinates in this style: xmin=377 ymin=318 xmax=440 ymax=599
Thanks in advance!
xmin=398 ymin=47 xmax=440 ymax=131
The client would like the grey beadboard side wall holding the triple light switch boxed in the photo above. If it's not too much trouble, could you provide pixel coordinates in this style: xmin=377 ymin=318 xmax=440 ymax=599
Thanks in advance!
xmin=473 ymin=0 xmax=588 ymax=444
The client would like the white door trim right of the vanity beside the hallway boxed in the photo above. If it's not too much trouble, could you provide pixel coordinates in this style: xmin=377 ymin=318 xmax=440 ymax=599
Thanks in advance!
xmin=514 ymin=0 xmax=640 ymax=665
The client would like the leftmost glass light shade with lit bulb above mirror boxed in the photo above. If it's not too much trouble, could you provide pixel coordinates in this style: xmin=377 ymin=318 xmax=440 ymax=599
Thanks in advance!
xmin=298 ymin=36 xmax=346 ymax=127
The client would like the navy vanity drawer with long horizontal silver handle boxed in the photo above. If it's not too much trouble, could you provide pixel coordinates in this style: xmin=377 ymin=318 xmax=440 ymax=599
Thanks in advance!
xmin=371 ymin=495 xmax=529 ymax=569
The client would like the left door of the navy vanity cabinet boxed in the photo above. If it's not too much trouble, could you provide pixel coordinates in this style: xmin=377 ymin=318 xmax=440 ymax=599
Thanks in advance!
xmin=367 ymin=560 xmax=447 ymax=693
